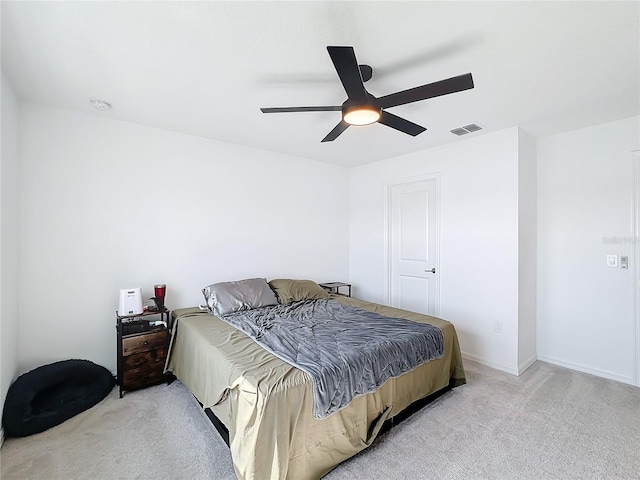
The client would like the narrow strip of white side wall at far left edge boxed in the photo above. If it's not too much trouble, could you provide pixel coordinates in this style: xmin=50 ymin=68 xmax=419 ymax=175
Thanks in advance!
xmin=0 ymin=74 xmax=18 ymax=426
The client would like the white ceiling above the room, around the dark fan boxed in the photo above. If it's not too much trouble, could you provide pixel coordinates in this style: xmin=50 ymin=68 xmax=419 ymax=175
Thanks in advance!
xmin=1 ymin=1 xmax=640 ymax=166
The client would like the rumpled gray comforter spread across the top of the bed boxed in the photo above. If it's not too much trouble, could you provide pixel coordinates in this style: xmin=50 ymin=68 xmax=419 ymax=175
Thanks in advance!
xmin=222 ymin=300 xmax=444 ymax=418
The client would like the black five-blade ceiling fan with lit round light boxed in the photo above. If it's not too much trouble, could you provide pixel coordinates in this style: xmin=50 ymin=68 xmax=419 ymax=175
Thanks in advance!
xmin=260 ymin=46 xmax=473 ymax=142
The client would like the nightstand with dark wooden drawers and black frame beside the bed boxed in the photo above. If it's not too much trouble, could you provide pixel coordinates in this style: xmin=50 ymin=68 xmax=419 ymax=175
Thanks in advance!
xmin=116 ymin=308 xmax=173 ymax=398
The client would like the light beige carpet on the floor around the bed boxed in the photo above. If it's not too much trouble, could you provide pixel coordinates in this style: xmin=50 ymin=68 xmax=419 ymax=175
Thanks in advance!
xmin=0 ymin=362 xmax=640 ymax=480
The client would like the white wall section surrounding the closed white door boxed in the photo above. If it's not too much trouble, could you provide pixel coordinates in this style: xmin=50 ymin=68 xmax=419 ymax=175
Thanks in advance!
xmin=350 ymin=127 xmax=520 ymax=374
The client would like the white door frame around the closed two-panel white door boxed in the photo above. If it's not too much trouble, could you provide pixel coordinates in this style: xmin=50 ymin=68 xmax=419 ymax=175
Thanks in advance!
xmin=384 ymin=172 xmax=442 ymax=317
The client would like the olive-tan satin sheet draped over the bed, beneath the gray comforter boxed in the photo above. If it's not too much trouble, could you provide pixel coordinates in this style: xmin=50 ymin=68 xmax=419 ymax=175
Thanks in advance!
xmin=166 ymin=281 xmax=465 ymax=480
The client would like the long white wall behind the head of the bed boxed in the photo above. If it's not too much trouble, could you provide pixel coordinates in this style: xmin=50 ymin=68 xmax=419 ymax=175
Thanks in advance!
xmin=19 ymin=103 xmax=349 ymax=371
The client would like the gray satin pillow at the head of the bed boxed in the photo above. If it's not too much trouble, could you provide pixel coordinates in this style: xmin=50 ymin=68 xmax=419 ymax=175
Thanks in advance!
xmin=202 ymin=278 xmax=278 ymax=316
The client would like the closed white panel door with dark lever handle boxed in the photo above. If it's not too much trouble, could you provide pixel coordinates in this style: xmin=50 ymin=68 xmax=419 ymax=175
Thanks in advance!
xmin=387 ymin=178 xmax=439 ymax=315
